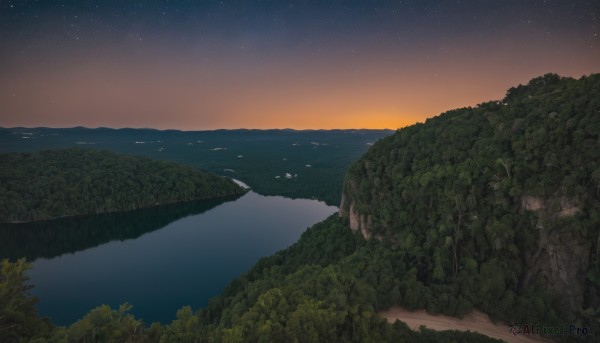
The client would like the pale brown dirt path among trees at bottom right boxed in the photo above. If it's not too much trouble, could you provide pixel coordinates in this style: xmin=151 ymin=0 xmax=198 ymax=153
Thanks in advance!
xmin=379 ymin=307 xmax=552 ymax=343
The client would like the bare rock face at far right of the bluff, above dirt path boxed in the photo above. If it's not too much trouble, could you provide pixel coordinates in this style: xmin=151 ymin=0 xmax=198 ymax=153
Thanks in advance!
xmin=521 ymin=196 xmax=592 ymax=311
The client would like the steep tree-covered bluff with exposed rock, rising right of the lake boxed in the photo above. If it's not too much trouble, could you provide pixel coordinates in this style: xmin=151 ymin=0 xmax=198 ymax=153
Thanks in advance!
xmin=340 ymin=74 xmax=600 ymax=318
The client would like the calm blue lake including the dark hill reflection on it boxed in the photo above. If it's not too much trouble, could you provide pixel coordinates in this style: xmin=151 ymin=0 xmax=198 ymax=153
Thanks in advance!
xmin=0 ymin=191 xmax=337 ymax=325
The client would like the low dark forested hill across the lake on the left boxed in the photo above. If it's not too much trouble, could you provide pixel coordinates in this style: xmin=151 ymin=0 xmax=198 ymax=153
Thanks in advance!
xmin=0 ymin=149 xmax=244 ymax=222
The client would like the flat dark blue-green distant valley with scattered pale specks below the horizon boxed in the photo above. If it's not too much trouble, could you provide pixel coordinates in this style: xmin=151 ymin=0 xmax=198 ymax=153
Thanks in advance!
xmin=0 ymin=127 xmax=393 ymax=206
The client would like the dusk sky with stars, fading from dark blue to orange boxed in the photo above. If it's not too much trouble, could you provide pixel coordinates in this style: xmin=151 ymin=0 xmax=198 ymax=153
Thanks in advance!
xmin=0 ymin=0 xmax=600 ymax=130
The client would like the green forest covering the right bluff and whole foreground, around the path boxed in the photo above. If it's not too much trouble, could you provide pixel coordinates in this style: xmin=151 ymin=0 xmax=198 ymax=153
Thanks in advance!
xmin=0 ymin=74 xmax=600 ymax=342
